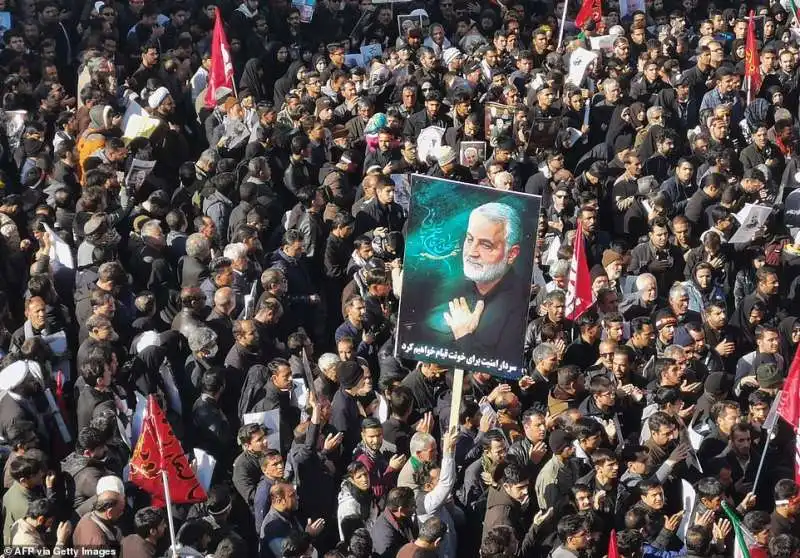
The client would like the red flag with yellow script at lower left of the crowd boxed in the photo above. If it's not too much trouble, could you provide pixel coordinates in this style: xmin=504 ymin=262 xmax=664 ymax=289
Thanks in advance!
xmin=130 ymin=395 xmax=208 ymax=507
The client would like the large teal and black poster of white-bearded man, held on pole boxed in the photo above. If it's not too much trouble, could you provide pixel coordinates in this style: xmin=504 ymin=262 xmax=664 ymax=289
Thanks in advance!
xmin=396 ymin=175 xmax=541 ymax=378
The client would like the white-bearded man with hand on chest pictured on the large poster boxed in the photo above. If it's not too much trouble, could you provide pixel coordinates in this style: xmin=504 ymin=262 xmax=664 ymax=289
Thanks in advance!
xmin=443 ymin=203 xmax=530 ymax=361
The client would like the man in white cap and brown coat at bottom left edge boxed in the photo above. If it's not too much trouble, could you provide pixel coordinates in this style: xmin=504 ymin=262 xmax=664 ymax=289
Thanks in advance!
xmin=72 ymin=475 xmax=125 ymax=556
